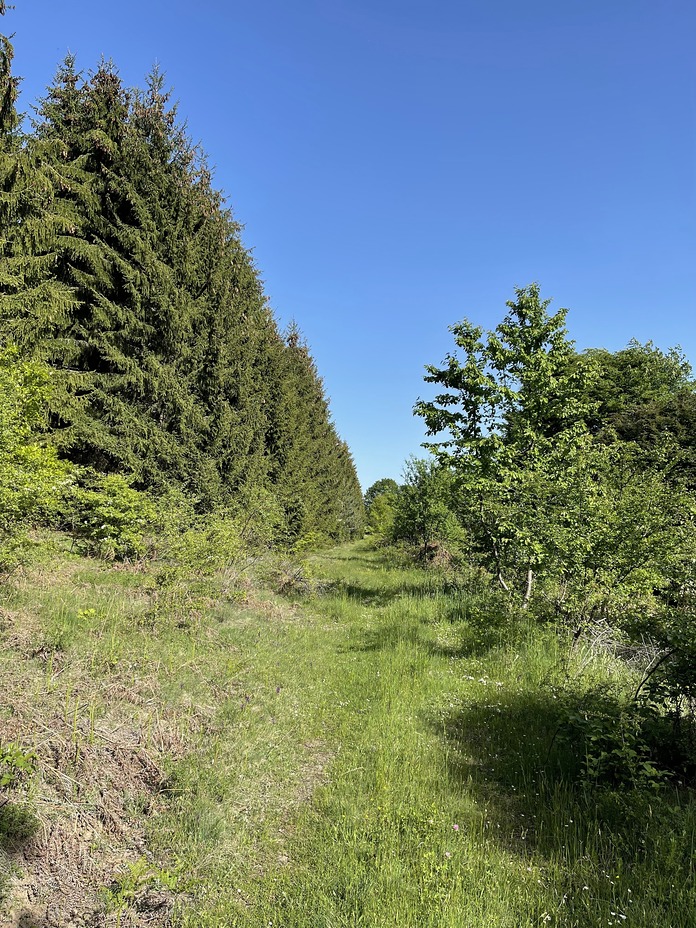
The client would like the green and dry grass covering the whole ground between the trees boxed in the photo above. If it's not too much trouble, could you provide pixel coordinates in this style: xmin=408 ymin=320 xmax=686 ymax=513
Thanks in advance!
xmin=0 ymin=543 xmax=696 ymax=928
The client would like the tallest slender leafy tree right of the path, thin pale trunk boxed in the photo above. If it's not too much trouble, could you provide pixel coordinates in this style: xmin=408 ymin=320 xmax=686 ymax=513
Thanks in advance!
xmin=415 ymin=284 xmax=589 ymax=600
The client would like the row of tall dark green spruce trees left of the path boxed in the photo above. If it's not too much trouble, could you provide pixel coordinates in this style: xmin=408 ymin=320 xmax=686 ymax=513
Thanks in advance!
xmin=0 ymin=0 xmax=362 ymax=540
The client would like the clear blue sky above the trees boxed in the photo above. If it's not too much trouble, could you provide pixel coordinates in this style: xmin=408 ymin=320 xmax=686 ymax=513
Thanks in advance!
xmin=12 ymin=0 xmax=696 ymax=487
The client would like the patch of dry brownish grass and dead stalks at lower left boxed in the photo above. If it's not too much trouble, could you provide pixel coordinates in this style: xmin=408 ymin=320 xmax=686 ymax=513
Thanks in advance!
xmin=0 ymin=612 xmax=182 ymax=926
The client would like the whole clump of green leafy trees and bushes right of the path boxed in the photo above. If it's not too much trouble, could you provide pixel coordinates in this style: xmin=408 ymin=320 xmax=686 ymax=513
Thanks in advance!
xmin=414 ymin=285 xmax=696 ymax=712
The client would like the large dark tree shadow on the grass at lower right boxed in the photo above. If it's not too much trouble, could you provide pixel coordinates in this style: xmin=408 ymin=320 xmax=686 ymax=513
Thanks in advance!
xmin=429 ymin=684 xmax=696 ymax=928
